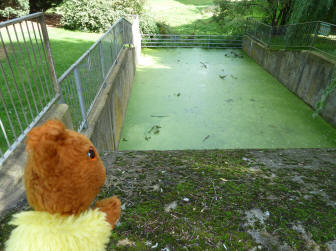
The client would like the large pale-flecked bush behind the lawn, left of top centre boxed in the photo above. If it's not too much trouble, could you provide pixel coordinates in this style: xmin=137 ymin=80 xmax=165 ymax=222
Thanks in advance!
xmin=59 ymin=0 xmax=144 ymax=32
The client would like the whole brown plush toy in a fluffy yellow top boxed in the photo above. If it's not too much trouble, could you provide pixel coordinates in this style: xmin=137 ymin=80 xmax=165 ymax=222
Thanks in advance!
xmin=6 ymin=120 xmax=121 ymax=251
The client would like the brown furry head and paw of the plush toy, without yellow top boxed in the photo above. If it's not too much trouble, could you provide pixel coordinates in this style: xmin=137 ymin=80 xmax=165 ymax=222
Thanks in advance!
xmin=25 ymin=120 xmax=121 ymax=227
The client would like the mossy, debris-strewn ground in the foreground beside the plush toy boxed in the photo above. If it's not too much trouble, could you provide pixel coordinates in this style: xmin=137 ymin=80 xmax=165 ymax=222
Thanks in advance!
xmin=0 ymin=149 xmax=336 ymax=250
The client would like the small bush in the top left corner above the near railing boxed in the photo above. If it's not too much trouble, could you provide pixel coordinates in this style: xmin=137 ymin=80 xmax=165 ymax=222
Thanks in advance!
xmin=0 ymin=0 xmax=29 ymax=19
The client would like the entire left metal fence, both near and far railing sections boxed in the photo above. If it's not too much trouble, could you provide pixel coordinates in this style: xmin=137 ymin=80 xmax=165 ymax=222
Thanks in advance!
xmin=0 ymin=13 xmax=132 ymax=164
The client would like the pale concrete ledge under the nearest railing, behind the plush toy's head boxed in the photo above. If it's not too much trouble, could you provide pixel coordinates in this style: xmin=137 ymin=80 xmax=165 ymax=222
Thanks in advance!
xmin=0 ymin=104 xmax=73 ymax=215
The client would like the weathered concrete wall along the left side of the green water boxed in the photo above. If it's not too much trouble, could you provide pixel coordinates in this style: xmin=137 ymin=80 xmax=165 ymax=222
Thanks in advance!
xmin=82 ymin=48 xmax=136 ymax=153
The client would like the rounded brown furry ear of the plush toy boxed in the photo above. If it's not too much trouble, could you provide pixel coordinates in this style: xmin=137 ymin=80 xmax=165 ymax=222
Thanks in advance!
xmin=26 ymin=120 xmax=66 ymax=175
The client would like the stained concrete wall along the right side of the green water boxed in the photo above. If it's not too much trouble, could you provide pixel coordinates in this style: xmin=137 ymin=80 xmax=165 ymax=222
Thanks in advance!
xmin=243 ymin=36 xmax=336 ymax=127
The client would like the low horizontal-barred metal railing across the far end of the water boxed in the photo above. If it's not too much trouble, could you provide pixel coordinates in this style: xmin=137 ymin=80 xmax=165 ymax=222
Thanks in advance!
xmin=141 ymin=34 xmax=242 ymax=49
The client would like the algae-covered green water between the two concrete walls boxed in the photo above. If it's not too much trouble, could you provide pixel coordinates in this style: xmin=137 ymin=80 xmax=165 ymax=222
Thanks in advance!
xmin=119 ymin=48 xmax=336 ymax=150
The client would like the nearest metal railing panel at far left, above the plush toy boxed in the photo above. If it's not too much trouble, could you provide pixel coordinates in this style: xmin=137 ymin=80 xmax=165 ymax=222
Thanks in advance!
xmin=0 ymin=13 xmax=60 ymax=164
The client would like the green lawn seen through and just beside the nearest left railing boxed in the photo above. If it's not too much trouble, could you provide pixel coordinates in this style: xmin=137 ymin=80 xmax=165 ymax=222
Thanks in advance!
xmin=0 ymin=27 xmax=101 ymax=152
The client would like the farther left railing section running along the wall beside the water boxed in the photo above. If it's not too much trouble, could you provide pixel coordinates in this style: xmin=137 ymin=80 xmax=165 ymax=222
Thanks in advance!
xmin=58 ymin=18 xmax=132 ymax=131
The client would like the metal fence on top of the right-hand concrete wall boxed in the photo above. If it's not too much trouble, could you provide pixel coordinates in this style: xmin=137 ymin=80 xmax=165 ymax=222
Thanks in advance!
xmin=246 ymin=19 xmax=336 ymax=58
